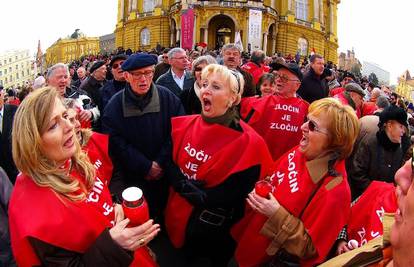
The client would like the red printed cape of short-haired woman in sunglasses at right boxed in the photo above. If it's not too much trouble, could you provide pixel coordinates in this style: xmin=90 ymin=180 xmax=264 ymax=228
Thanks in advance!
xmin=233 ymin=147 xmax=351 ymax=267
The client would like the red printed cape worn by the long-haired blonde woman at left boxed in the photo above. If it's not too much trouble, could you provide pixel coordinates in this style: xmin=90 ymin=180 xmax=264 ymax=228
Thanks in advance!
xmin=9 ymin=165 xmax=156 ymax=267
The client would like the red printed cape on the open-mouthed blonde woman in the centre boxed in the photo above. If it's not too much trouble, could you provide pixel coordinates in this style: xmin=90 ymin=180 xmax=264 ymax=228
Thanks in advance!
xmin=165 ymin=115 xmax=271 ymax=247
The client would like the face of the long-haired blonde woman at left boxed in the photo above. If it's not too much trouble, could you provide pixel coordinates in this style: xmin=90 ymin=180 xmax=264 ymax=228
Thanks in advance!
xmin=41 ymin=98 xmax=76 ymax=165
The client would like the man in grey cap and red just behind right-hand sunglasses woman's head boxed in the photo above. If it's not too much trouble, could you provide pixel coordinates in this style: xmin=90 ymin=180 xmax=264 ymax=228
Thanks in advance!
xmin=334 ymin=83 xmax=365 ymax=118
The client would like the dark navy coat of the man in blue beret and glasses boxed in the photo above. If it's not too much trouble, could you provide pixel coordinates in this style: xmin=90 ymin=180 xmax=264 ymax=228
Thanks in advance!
xmin=102 ymin=84 xmax=185 ymax=219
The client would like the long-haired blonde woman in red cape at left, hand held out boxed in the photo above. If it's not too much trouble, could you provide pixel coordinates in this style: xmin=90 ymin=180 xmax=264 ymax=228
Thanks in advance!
xmin=9 ymin=87 xmax=159 ymax=266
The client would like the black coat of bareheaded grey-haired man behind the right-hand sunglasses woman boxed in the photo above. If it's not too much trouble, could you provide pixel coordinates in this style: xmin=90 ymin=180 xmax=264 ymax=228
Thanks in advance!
xmin=298 ymin=68 xmax=329 ymax=104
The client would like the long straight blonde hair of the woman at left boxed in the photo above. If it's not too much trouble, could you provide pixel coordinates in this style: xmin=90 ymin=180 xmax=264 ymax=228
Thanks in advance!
xmin=12 ymin=86 xmax=95 ymax=201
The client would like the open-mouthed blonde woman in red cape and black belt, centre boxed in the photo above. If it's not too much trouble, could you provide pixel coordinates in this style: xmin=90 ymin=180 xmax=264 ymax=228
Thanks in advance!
xmin=165 ymin=64 xmax=271 ymax=266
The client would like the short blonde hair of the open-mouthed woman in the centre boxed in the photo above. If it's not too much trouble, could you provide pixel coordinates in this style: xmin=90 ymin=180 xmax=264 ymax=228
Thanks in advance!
xmin=201 ymin=64 xmax=244 ymax=106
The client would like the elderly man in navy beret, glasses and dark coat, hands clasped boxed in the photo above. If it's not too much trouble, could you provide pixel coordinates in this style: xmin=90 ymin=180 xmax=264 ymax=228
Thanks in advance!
xmin=102 ymin=53 xmax=185 ymax=218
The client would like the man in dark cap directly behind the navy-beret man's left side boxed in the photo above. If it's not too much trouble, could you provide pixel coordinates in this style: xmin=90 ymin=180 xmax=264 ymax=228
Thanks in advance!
xmin=100 ymin=54 xmax=128 ymax=112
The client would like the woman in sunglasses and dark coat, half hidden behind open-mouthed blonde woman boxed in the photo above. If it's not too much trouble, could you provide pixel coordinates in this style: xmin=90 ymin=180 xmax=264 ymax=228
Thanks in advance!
xmin=180 ymin=55 xmax=217 ymax=115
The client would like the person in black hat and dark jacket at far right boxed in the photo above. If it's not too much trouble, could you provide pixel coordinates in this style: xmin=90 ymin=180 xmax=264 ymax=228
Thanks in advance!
xmin=347 ymin=105 xmax=408 ymax=199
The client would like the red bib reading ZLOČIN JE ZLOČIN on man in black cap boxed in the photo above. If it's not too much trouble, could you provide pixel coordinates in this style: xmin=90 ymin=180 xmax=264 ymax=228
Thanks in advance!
xmin=240 ymin=95 xmax=309 ymax=160
